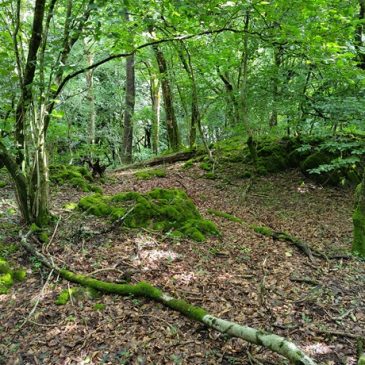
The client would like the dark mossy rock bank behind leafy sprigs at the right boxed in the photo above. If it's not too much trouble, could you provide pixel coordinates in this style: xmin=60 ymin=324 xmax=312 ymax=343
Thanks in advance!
xmin=247 ymin=135 xmax=365 ymax=185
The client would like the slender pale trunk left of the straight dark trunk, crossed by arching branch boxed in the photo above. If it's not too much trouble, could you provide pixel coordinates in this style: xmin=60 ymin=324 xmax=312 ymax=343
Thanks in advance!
xmin=84 ymin=40 xmax=96 ymax=145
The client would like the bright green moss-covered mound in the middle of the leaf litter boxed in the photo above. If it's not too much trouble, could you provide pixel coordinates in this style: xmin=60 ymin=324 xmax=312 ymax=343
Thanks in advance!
xmin=79 ymin=189 xmax=219 ymax=242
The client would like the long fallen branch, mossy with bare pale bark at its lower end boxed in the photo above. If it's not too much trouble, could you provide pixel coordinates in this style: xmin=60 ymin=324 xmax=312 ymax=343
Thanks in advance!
xmin=21 ymin=233 xmax=315 ymax=365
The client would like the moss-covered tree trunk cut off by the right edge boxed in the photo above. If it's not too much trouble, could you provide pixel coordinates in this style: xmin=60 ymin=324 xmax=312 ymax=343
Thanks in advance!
xmin=352 ymin=170 xmax=365 ymax=257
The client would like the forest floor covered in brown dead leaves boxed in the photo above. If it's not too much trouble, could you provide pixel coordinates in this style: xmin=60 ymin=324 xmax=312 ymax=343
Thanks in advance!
xmin=0 ymin=164 xmax=365 ymax=365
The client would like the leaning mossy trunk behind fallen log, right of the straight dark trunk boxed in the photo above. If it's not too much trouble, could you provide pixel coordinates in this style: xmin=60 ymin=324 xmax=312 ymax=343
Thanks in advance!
xmin=153 ymin=45 xmax=180 ymax=151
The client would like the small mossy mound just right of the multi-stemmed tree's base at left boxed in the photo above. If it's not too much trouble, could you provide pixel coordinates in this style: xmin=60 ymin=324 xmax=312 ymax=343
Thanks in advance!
xmin=50 ymin=165 xmax=101 ymax=192
